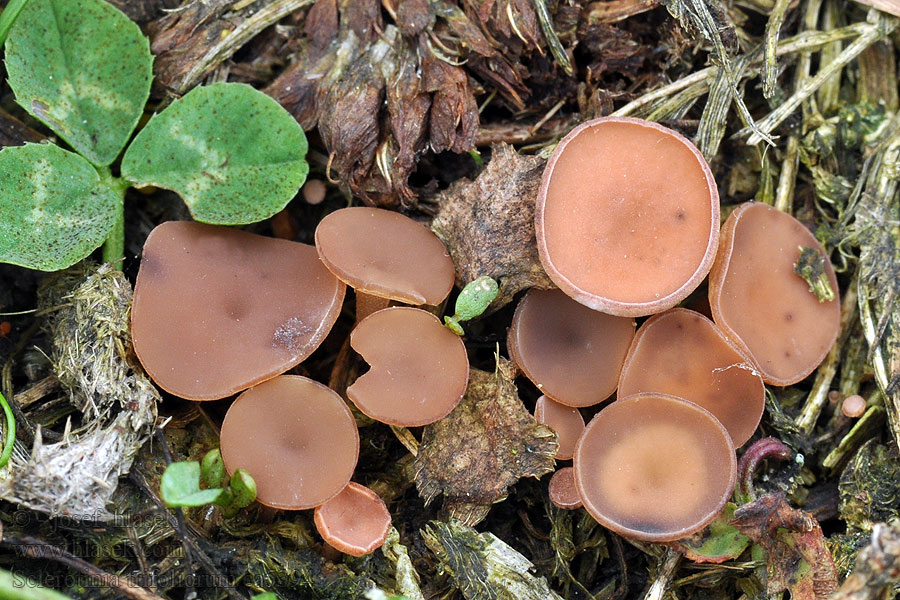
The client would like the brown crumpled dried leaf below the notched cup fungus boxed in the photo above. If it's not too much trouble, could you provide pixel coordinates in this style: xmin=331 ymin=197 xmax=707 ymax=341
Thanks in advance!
xmin=415 ymin=357 xmax=559 ymax=525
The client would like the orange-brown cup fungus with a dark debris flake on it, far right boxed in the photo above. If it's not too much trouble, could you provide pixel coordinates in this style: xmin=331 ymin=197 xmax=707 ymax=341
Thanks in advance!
xmin=709 ymin=203 xmax=841 ymax=386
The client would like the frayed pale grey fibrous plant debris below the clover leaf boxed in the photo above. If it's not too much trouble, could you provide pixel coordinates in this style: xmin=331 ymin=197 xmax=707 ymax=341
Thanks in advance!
xmin=0 ymin=264 xmax=159 ymax=520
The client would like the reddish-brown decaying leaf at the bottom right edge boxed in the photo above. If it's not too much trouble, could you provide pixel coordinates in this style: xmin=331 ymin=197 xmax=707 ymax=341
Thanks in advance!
xmin=732 ymin=494 xmax=837 ymax=600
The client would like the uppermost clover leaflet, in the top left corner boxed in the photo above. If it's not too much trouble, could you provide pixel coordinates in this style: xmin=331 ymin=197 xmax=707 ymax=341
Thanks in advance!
xmin=6 ymin=0 xmax=153 ymax=165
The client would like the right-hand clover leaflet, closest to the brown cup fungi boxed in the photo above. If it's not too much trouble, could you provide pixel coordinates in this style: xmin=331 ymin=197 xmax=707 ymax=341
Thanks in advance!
xmin=122 ymin=83 xmax=309 ymax=225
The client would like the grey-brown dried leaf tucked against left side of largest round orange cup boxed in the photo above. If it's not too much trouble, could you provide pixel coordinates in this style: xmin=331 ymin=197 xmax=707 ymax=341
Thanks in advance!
xmin=431 ymin=144 xmax=553 ymax=310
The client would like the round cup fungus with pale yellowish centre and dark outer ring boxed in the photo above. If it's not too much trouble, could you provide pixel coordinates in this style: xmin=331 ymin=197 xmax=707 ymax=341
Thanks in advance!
xmin=574 ymin=394 xmax=737 ymax=542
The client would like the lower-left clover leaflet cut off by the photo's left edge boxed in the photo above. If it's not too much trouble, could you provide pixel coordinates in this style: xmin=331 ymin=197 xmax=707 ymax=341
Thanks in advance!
xmin=0 ymin=144 xmax=122 ymax=271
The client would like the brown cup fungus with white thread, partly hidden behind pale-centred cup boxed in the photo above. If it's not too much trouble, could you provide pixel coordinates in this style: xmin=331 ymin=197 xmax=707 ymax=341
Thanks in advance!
xmin=618 ymin=308 xmax=766 ymax=447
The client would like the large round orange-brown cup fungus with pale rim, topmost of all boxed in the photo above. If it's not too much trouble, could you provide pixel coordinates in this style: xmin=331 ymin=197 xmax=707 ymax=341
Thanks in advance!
xmin=535 ymin=117 xmax=719 ymax=317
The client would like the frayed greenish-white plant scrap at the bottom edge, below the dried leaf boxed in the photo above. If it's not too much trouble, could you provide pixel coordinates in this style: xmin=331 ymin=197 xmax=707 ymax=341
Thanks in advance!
xmin=422 ymin=521 xmax=562 ymax=600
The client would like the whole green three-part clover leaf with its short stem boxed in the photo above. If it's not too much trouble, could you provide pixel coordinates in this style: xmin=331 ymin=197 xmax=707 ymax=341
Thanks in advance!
xmin=0 ymin=0 xmax=309 ymax=271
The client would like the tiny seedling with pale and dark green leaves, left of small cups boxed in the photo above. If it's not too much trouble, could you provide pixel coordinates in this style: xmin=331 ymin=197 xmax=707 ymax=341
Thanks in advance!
xmin=160 ymin=449 xmax=256 ymax=517
